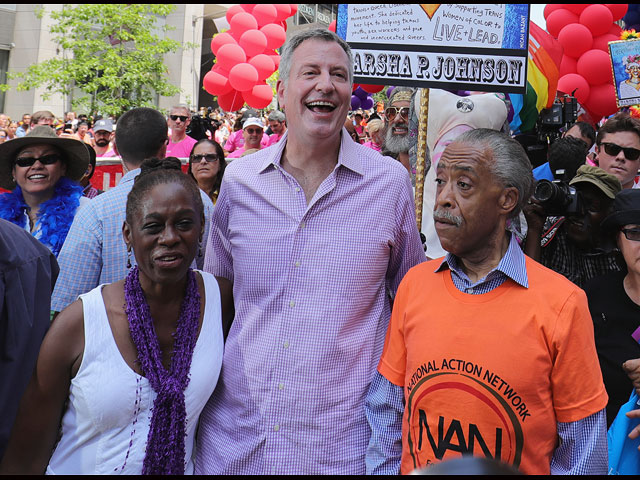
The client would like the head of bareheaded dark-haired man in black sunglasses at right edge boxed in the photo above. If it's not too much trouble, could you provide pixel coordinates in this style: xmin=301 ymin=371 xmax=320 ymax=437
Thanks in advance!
xmin=595 ymin=113 xmax=640 ymax=189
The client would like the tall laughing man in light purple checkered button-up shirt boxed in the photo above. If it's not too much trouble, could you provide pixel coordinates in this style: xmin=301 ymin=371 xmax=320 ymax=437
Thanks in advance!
xmin=196 ymin=30 xmax=425 ymax=475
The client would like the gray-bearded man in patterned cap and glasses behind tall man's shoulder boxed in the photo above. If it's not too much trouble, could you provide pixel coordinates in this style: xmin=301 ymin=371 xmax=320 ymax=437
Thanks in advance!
xmin=382 ymin=87 xmax=417 ymax=173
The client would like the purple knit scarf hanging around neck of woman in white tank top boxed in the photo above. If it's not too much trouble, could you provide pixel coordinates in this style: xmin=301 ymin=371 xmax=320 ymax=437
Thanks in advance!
xmin=124 ymin=266 xmax=200 ymax=475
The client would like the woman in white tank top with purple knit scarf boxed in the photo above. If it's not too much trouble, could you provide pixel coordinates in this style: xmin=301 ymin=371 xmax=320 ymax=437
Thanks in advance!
xmin=0 ymin=160 xmax=233 ymax=475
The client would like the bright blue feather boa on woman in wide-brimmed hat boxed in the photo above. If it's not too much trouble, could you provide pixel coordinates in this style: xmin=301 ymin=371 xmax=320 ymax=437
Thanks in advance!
xmin=0 ymin=177 xmax=82 ymax=257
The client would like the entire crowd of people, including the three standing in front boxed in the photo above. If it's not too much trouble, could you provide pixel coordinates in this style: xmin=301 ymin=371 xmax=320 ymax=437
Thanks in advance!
xmin=0 ymin=29 xmax=640 ymax=474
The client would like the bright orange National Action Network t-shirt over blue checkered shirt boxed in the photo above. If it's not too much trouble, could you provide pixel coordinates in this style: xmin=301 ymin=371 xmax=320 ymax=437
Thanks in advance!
xmin=378 ymin=257 xmax=607 ymax=475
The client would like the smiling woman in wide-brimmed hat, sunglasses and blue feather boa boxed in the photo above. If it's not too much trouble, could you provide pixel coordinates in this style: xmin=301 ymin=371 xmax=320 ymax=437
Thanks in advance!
xmin=0 ymin=125 xmax=89 ymax=256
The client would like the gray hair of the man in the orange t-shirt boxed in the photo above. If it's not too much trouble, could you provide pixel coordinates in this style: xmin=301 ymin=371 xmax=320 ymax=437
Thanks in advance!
xmin=454 ymin=128 xmax=534 ymax=218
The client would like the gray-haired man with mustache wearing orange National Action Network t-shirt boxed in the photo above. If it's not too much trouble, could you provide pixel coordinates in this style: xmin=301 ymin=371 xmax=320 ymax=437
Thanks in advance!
xmin=366 ymin=129 xmax=607 ymax=475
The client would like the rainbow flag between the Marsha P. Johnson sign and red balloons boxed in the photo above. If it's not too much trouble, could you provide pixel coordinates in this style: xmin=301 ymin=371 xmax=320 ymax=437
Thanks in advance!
xmin=509 ymin=22 xmax=562 ymax=133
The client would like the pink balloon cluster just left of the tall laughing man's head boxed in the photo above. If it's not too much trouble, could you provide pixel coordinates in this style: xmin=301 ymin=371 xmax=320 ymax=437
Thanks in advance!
xmin=202 ymin=4 xmax=298 ymax=112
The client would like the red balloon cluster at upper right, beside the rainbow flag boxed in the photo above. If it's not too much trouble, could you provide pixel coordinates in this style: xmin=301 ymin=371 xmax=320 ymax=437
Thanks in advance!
xmin=544 ymin=4 xmax=627 ymax=121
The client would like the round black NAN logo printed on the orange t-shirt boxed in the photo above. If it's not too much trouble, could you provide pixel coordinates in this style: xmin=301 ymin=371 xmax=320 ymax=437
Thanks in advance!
xmin=406 ymin=359 xmax=531 ymax=468
